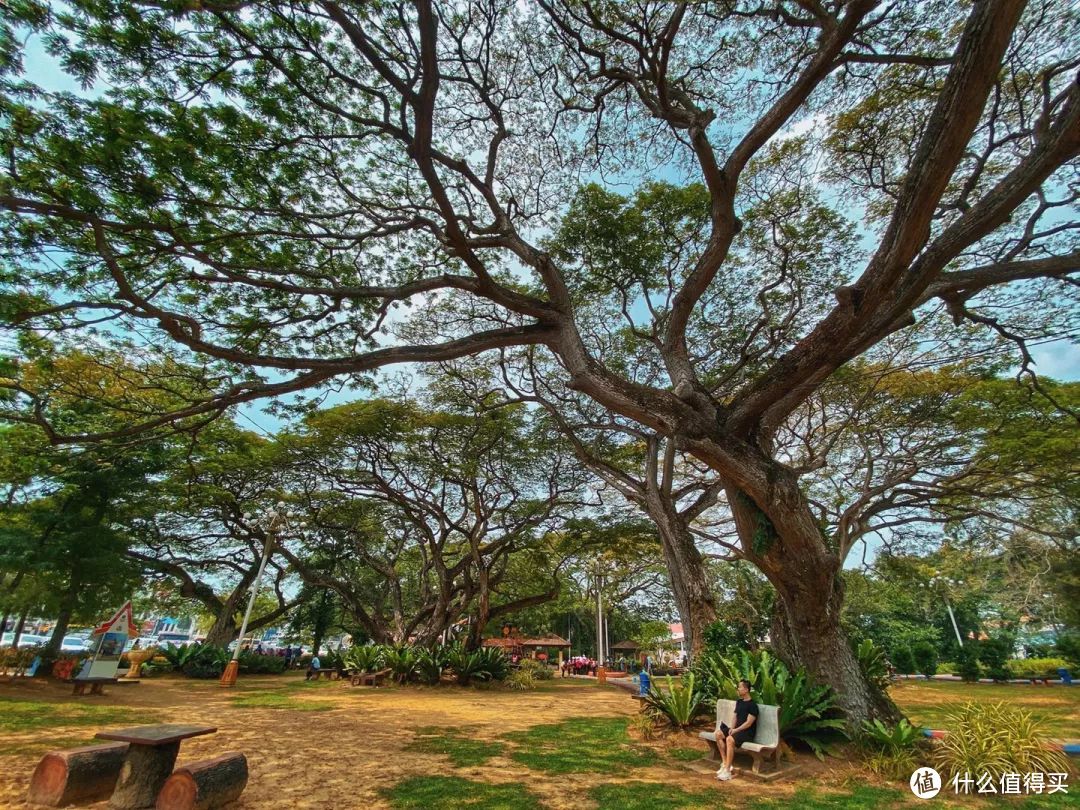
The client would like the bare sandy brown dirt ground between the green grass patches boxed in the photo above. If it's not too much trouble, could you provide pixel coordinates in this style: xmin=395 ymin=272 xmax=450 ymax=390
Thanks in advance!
xmin=0 ymin=675 xmax=860 ymax=810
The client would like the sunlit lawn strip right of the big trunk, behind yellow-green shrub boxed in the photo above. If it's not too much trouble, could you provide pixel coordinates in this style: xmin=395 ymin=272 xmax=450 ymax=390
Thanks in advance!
xmin=889 ymin=680 xmax=1080 ymax=739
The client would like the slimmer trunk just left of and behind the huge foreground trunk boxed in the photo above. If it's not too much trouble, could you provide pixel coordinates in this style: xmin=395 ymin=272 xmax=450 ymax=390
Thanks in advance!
xmin=645 ymin=491 xmax=716 ymax=660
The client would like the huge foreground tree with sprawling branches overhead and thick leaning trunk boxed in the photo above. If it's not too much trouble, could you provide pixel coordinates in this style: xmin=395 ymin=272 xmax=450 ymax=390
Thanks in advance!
xmin=0 ymin=0 xmax=1080 ymax=721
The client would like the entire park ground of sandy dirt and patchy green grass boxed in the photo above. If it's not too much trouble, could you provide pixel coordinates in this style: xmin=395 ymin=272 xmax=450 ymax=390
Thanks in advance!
xmin=0 ymin=674 xmax=1080 ymax=810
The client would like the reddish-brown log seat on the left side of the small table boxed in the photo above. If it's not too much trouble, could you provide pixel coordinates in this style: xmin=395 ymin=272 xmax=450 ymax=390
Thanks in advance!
xmin=27 ymin=742 xmax=127 ymax=807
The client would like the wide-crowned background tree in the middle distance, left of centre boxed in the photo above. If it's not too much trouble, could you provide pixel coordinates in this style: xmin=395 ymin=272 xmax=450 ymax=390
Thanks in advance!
xmin=281 ymin=400 xmax=582 ymax=646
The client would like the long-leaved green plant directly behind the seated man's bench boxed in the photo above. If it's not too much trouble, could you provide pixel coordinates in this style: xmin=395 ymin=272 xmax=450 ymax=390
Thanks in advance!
xmin=696 ymin=650 xmax=847 ymax=758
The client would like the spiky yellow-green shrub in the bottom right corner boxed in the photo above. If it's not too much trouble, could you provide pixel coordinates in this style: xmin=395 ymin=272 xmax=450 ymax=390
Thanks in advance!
xmin=933 ymin=702 xmax=1068 ymax=782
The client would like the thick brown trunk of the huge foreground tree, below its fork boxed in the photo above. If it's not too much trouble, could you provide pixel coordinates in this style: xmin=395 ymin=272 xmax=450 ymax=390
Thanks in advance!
xmin=728 ymin=483 xmax=900 ymax=729
